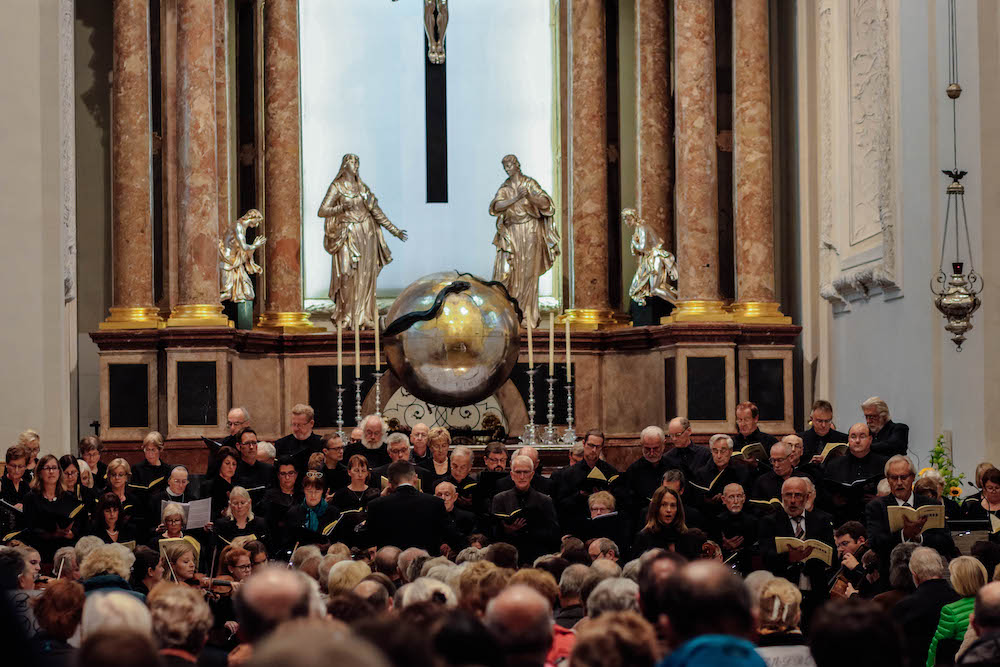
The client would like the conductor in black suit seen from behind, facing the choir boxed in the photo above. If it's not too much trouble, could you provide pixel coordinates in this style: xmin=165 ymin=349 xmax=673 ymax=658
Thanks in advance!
xmin=366 ymin=459 xmax=452 ymax=554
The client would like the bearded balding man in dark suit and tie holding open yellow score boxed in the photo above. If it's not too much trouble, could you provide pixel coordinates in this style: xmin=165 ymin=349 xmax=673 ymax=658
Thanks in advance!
xmin=759 ymin=477 xmax=834 ymax=618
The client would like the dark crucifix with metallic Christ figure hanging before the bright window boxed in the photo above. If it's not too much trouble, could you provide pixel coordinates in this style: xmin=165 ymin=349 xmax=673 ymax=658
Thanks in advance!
xmin=393 ymin=0 xmax=448 ymax=204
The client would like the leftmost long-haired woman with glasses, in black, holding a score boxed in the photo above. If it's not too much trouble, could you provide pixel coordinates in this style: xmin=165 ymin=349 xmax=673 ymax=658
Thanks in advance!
xmin=21 ymin=454 xmax=86 ymax=563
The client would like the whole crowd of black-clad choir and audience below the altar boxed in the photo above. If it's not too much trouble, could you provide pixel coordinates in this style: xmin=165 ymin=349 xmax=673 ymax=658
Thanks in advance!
xmin=0 ymin=397 xmax=1000 ymax=667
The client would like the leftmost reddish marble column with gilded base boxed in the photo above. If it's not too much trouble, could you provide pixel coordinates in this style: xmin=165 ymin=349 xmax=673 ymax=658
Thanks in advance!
xmin=99 ymin=0 xmax=163 ymax=329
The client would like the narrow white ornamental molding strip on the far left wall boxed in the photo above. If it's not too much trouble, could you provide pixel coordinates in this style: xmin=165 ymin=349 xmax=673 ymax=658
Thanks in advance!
xmin=59 ymin=0 xmax=76 ymax=303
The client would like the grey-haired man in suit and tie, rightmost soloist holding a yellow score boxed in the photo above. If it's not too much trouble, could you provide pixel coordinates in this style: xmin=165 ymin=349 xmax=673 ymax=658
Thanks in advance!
xmin=865 ymin=455 xmax=958 ymax=580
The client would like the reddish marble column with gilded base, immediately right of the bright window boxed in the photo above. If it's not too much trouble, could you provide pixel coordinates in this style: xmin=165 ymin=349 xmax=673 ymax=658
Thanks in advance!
xmin=564 ymin=0 xmax=620 ymax=329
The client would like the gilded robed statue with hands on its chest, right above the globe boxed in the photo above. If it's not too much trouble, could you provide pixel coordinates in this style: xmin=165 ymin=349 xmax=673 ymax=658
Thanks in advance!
xmin=490 ymin=155 xmax=559 ymax=328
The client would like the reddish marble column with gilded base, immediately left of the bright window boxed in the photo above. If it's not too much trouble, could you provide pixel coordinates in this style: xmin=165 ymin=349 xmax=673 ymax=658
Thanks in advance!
xmin=258 ymin=0 xmax=319 ymax=333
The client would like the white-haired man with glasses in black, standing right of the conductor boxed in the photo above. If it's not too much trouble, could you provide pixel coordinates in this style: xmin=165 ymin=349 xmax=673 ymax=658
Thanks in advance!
xmin=494 ymin=455 xmax=564 ymax=563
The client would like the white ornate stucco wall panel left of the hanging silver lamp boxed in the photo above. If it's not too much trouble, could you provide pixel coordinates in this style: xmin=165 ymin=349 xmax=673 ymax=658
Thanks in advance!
xmin=817 ymin=0 xmax=901 ymax=310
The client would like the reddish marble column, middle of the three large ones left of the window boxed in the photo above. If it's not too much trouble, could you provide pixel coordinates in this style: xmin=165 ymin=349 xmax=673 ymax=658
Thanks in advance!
xmin=167 ymin=0 xmax=229 ymax=327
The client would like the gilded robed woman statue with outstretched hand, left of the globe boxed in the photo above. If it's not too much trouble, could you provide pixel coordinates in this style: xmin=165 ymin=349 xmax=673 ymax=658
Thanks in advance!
xmin=318 ymin=153 xmax=407 ymax=329
